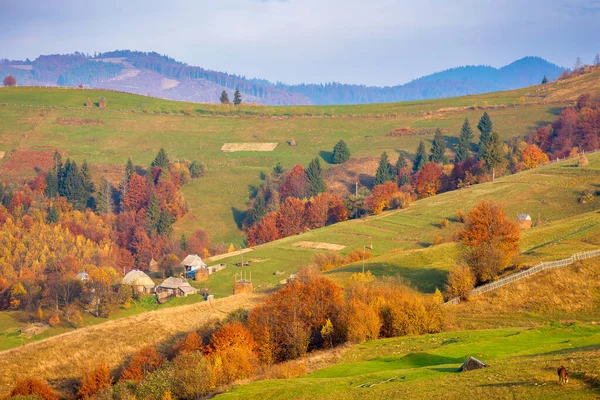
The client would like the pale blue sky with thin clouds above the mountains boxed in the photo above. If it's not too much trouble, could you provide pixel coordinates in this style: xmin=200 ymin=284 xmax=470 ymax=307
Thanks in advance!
xmin=0 ymin=0 xmax=600 ymax=86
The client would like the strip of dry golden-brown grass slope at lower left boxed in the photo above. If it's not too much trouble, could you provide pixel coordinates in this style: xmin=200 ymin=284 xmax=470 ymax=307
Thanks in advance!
xmin=0 ymin=293 xmax=264 ymax=395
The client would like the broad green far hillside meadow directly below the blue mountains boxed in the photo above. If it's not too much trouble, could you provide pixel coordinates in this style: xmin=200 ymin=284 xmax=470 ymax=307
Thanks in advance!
xmin=0 ymin=71 xmax=600 ymax=247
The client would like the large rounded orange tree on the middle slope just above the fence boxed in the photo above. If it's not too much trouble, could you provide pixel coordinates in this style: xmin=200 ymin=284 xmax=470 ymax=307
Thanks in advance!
xmin=458 ymin=201 xmax=520 ymax=283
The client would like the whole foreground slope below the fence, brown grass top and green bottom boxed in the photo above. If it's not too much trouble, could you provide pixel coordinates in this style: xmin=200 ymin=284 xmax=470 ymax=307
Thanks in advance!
xmin=217 ymin=259 xmax=600 ymax=399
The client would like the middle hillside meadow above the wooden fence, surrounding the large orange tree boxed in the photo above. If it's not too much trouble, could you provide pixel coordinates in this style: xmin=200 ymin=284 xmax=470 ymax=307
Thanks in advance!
xmin=201 ymin=152 xmax=600 ymax=296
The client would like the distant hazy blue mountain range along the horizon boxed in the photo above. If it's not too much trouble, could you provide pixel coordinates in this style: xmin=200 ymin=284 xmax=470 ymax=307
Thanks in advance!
xmin=0 ymin=50 xmax=564 ymax=105
